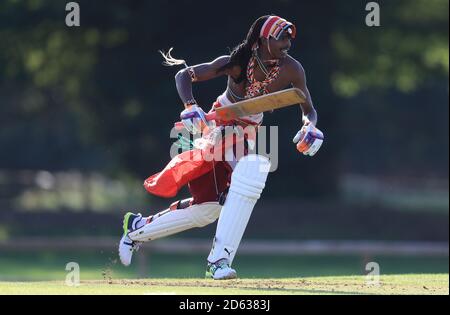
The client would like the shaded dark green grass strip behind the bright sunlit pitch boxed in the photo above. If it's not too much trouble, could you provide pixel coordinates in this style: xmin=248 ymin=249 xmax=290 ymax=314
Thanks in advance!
xmin=0 ymin=251 xmax=449 ymax=281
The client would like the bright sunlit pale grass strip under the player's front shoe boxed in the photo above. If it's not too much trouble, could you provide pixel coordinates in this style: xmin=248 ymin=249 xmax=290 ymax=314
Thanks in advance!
xmin=0 ymin=274 xmax=449 ymax=295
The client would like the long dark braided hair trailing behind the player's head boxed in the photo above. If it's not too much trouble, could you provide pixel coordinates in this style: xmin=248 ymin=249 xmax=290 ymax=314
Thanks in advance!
xmin=217 ymin=15 xmax=270 ymax=84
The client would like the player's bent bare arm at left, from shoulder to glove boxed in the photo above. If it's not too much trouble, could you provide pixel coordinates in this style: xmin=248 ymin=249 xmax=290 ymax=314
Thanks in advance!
xmin=175 ymin=56 xmax=230 ymax=107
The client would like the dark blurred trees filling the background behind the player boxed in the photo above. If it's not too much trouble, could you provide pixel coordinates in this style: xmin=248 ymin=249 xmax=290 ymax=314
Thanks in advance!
xmin=0 ymin=0 xmax=449 ymax=239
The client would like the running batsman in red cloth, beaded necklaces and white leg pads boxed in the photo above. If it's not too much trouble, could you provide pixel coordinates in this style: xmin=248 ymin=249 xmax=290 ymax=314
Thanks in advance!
xmin=119 ymin=15 xmax=323 ymax=280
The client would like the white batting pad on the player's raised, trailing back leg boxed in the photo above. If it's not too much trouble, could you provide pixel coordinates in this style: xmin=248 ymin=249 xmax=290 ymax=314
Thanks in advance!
xmin=128 ymin=202 xmax=222 ymax=242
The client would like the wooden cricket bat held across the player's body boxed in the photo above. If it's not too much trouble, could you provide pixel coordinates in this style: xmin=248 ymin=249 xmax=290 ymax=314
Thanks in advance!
xmin=175 ymin=88 xmax=306 ymax=129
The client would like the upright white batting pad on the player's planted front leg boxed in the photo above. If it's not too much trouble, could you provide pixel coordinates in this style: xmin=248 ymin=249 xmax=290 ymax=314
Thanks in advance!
xmin=208 ymin=154 xmax=270 ymax=265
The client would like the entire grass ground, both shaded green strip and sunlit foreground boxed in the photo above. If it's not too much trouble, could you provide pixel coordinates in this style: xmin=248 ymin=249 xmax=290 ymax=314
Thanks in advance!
xmin=0 ymin=251 xmax=449 ymax=295
